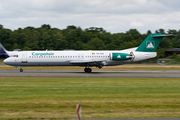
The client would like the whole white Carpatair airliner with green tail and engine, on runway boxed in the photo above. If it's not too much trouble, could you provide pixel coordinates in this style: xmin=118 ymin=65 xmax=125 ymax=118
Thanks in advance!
xmin=0 ymin=33 xmax=172 ymax=73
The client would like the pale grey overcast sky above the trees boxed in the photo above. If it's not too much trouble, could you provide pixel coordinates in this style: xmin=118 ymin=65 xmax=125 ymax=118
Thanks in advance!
xmin=0 ymin=0 xmax=180 ymax=33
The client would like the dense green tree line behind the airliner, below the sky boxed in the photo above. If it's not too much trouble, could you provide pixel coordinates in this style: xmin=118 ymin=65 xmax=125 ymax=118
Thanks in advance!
xmin=0 ymin=24 xmax=180 ymax=57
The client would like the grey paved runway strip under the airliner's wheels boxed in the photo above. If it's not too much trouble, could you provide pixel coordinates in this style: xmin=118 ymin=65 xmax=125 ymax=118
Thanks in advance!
xmin=0 ymin=70 xmax=180 ymax=78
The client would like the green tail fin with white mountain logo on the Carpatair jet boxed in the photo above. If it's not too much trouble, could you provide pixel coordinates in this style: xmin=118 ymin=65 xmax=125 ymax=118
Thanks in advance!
xmin=136 ymin=33 xmax=172 ymax=52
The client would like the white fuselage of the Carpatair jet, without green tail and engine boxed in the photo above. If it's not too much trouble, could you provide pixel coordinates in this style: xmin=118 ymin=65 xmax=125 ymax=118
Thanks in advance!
xmin=4 ymin=48 xmax=156 ymax=66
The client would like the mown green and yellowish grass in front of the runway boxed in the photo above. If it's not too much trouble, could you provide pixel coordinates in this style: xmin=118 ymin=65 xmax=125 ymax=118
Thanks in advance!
xmin=0 ymin=77 xmax=180 ymax=120
